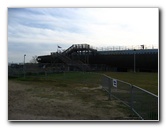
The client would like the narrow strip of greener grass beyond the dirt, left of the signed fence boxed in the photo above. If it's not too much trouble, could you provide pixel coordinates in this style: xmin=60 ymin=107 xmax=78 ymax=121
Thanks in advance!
xmin=15 ymin=72 xmax=100 ymax=86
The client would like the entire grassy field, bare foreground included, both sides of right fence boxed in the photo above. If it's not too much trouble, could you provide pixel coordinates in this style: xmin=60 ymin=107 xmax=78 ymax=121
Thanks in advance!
xmin=8 ymin=72 xmax=158 ymax=120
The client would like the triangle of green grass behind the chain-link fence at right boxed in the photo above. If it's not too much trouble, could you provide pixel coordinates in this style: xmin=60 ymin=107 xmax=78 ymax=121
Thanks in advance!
xmin=104 ymin=72 xmax=159 ymax=95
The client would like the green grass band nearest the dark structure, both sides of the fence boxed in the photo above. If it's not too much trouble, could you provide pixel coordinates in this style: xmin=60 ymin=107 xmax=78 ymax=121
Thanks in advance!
xmin=10 ymin=72 xmax=158 ymax=95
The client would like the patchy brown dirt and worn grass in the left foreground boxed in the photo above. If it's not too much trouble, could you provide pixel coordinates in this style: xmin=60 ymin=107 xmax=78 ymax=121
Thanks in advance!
xmin=8 ymin=80 xmax=135 ymax=120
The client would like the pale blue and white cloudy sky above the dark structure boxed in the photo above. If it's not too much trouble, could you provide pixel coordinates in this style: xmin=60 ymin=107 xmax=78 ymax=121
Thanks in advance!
xmin=8 ymin=8 xmax=159 ymax=63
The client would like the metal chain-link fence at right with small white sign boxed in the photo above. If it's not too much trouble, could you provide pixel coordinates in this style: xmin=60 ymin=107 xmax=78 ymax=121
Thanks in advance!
xmin=101 ymin=75 xmax=159 ymax=120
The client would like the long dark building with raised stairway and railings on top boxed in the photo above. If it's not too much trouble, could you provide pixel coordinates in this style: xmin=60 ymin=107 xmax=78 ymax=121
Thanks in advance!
xmin=37 ymin=44 xmax=158 ymax=72
